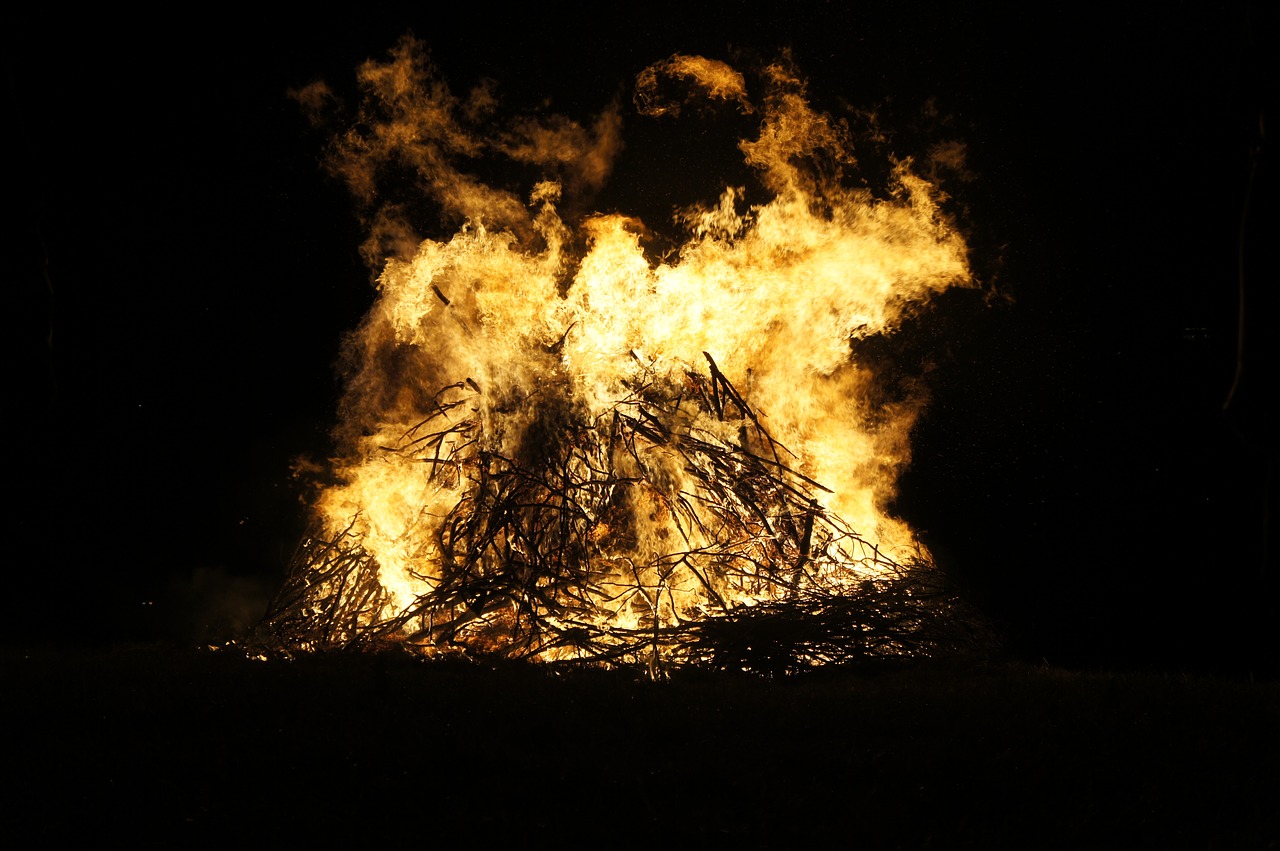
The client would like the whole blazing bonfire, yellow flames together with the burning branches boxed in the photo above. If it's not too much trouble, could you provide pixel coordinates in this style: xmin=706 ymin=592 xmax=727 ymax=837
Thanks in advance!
xmin=269 ymin=40 xmax=972 ymax=665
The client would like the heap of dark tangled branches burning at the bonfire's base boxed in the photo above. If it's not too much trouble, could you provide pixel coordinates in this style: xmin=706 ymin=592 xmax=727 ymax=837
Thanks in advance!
xmin=253 ymin=354 xmax=980 ymax=674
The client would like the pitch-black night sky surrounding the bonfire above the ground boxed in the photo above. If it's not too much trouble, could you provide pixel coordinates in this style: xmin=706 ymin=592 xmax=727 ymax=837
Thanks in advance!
xmin=5 ymin=3 xmax=1277 ymax=667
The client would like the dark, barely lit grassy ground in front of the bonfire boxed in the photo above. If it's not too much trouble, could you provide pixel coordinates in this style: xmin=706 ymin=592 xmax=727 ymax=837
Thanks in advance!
xmin=3 ymin=645 xmax=1280 ymax=848
